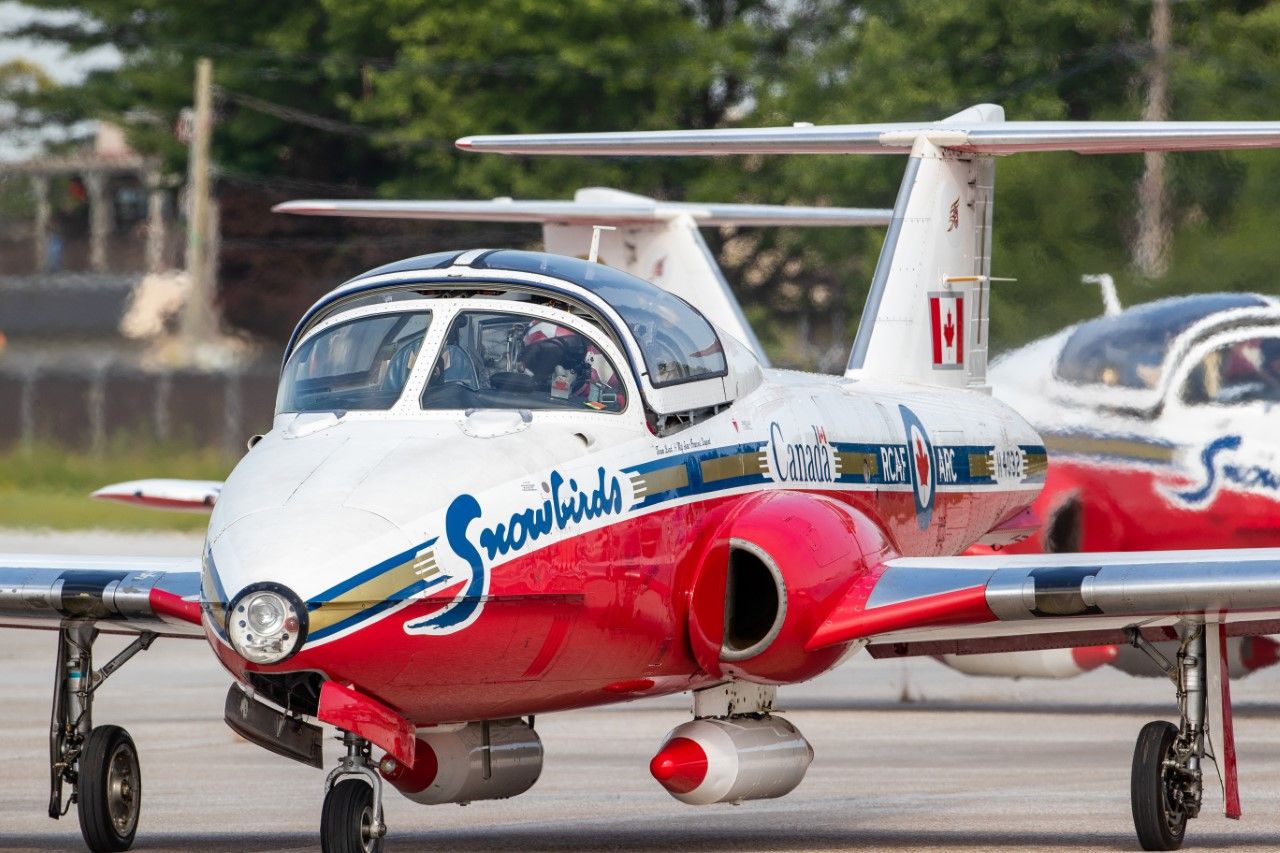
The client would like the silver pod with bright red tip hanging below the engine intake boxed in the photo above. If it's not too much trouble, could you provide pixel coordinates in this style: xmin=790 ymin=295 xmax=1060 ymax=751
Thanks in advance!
xmin=649 ymin=716 xmax=813 ymax=806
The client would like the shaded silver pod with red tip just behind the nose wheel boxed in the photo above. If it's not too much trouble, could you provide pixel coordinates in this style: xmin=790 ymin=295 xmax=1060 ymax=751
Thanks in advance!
xmin=378 ymin=720 xmax=543 ymax=806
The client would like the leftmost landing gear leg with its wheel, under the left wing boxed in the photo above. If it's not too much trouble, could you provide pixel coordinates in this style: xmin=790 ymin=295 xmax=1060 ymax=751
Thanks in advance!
xmin=49 ymin=622 xmax=156 ymax=852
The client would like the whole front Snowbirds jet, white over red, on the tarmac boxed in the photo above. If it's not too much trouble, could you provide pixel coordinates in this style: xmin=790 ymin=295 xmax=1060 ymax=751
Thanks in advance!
xmin=0 ymin=105 xmax=1280 ymax=852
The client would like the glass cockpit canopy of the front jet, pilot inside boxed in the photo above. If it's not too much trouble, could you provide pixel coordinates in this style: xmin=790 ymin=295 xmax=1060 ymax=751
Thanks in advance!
xmin=276 ymin=250 xmax=759 ymax=414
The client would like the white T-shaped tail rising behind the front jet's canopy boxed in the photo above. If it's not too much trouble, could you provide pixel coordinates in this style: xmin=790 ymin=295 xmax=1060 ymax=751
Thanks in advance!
xmin=273 ymin=187 xmax=891 ymax=365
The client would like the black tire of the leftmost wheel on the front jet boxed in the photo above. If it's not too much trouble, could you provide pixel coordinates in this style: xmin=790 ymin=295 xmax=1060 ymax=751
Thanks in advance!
xmin=76 ymin=726 xmax=142 ymax=853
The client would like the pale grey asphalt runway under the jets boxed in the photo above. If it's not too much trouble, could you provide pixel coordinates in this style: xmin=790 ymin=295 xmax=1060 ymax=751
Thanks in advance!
xmin=0 ymin=532 xmax=1280 ymax=852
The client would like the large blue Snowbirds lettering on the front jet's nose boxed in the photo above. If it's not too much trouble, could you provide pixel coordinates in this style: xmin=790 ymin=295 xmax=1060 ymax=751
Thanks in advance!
xmin=404 ymin=467 xmax=623 ymax=635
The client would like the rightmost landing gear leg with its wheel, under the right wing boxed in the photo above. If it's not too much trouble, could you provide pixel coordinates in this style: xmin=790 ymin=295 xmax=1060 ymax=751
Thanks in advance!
xmin=1130 ymin=625 xmax=1207 ymax=850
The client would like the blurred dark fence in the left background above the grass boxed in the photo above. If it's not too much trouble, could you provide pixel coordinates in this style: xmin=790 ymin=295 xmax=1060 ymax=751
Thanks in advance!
xmin=0 ymin=369 xmax=276 ymax=452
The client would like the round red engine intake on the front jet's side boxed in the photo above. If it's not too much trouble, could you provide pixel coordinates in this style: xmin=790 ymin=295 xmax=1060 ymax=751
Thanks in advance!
xmin=689 ymin=493 xmax=888 ymax=684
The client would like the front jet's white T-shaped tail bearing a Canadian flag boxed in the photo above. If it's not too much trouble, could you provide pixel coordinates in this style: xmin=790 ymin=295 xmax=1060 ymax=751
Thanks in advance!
xmin=457 ymin=104 xmax=1280 ymax=388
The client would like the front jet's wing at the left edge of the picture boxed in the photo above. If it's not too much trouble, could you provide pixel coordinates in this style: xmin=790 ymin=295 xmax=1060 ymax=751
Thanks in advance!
xmin=0 ymin=555 xmax=204 ymax=637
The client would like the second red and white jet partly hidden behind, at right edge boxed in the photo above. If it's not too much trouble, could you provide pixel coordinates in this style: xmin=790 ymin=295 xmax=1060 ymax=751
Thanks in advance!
xmin=943 ymin=295 xmax=1280 ymax=678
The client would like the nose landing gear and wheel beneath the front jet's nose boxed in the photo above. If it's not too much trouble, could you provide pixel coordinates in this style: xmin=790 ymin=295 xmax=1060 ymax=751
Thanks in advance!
xmin=320 ymin=731 xmax=387 ymax=853
